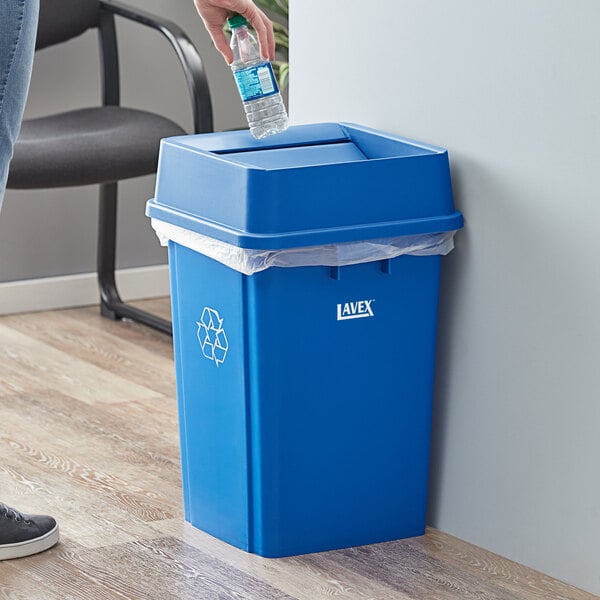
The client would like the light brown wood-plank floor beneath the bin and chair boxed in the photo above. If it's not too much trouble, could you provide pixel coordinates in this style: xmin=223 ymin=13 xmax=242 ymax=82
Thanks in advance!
xmin=0 ymin=300 xmax=595 ymax=600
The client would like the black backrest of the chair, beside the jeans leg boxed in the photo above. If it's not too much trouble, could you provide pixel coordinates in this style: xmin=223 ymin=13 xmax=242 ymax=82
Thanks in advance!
xmin=35 ymin=0 xmax=100 ymax=50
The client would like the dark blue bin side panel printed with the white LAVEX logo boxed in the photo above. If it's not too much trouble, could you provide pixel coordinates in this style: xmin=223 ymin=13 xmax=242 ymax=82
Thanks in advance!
xmin=248 ymin=256 xmax=440 ymax=557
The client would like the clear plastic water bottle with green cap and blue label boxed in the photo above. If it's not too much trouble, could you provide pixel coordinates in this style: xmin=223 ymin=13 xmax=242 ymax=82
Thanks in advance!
xmin=227 ymin=15 xmax=288 ymax=139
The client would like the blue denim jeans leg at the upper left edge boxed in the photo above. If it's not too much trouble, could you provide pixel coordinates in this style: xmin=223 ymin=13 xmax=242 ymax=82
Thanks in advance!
xmin=0 ymin=0 xmax=39 ymax=208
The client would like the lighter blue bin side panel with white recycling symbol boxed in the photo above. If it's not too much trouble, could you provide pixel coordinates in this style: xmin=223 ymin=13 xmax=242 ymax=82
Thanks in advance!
xmin=169 ymin=242 xmax=250 ymax=550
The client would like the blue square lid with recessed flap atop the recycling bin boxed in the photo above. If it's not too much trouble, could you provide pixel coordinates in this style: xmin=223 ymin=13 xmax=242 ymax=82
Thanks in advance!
xmin=146 ymin=123 xmax=462 ymax=249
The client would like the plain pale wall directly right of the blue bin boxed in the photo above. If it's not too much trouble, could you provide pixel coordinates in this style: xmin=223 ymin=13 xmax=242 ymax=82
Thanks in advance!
xmin=290 ymin=0 xmax=600 ymax=594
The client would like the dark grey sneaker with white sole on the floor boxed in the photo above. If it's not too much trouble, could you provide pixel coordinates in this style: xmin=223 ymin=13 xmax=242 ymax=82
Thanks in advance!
xmin=0 ymin=502 xmax=59 ymax=560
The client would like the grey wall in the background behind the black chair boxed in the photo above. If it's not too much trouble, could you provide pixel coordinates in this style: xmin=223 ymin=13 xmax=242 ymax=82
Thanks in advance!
xmin=0 ymin=0 xmax=245 ymax=286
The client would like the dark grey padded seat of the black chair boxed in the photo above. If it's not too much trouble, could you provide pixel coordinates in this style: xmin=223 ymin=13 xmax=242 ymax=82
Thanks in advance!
xmin=8 ymin=106 xmax=185 ymax=189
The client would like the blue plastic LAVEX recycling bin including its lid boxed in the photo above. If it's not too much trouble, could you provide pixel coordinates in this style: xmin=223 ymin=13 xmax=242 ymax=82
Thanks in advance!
xmin=147 ymin=123 xmax=462 ymax=557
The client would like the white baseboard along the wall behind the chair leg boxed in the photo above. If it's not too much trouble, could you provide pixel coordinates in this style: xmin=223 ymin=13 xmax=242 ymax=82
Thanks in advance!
xmin=0 ymin=265 xmax=170 ymax=315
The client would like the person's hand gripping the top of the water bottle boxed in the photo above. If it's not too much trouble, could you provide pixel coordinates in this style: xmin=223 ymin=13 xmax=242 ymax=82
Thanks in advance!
xmin=194 ymin=0 xmax=275 ymax=64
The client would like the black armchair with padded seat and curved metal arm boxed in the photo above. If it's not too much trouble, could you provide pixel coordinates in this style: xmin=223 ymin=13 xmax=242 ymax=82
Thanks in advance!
xmin=8 ymin=0 xmax=213 ymax=333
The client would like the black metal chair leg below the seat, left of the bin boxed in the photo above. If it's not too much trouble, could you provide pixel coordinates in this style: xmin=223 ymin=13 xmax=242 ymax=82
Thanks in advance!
xmin=97 ymin=183 xmax=173 ymax=335
